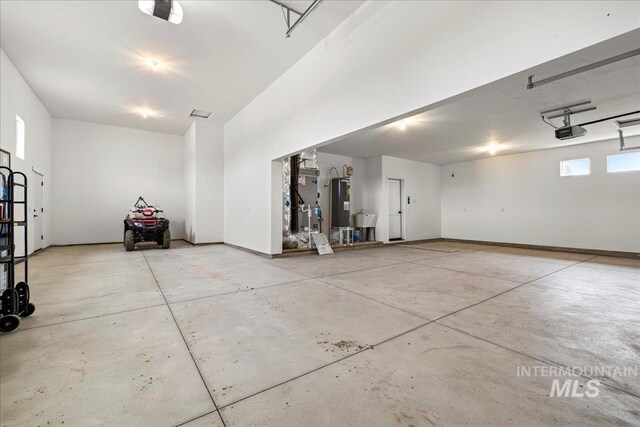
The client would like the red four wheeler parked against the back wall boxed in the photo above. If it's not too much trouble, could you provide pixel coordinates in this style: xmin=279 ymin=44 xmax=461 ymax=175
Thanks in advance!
xmin=124 ymin=196 xmax=171 ymax=251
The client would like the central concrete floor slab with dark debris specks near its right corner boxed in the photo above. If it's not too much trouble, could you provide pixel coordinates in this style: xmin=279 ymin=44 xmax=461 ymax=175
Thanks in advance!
xmin=171 ymin=280 xmax=425 ymax=405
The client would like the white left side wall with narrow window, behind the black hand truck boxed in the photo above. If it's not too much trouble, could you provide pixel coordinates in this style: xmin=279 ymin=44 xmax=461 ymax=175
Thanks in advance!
xmin=0 ymin=49 xmax=52 ymax=254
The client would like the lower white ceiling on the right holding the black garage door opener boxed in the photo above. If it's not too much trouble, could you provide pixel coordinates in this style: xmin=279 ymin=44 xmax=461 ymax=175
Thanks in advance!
xmin=320 ymin=30 xmax=640 ymax=164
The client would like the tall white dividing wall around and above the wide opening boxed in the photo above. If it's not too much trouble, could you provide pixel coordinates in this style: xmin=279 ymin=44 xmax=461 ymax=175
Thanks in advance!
xmin=224 ymin=1 xmax=640 ymax=253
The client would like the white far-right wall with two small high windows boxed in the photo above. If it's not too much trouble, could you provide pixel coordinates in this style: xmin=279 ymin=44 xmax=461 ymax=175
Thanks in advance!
xmin=441 ymin=137 xmax=640 ymax=252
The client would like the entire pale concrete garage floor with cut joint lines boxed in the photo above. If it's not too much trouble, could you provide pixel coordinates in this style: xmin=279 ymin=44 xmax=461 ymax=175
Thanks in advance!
xmin=0 ymin=242 xmax=640 ymax=426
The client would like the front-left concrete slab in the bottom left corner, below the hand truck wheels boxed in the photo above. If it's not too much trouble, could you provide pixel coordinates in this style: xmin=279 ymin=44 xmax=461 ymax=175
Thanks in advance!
xmin=0 ymin=306 xmax=215 ymax=426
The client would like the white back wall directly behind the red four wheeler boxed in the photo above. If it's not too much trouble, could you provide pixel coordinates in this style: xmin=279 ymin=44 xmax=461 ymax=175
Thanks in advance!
xmin=52 ymin=119 xmax=185 ymax=244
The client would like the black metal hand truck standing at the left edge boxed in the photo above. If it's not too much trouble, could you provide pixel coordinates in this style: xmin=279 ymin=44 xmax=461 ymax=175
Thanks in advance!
xmin=0 ymin=166 xmax=36 ymax=332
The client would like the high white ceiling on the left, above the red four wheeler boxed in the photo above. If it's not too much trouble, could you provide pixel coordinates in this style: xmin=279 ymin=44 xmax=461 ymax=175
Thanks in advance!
xmin=0 ymin=0 xmax=364 ymax=135
